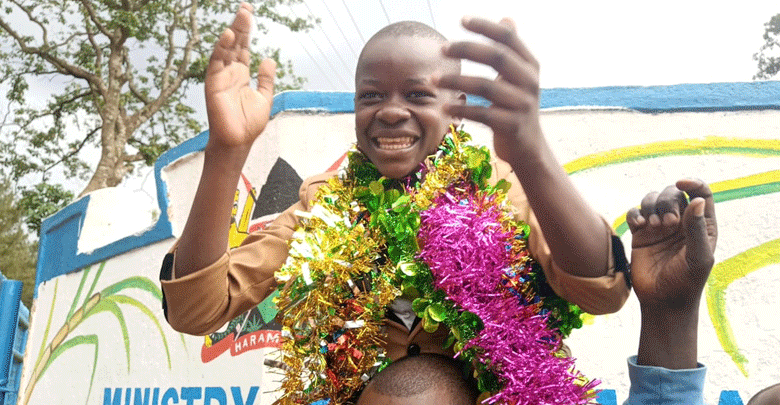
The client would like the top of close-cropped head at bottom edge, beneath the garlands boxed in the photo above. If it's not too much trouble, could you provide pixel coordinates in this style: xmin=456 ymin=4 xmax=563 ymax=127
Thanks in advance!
xmin=363 ymin=353 xmax=479 ymax=405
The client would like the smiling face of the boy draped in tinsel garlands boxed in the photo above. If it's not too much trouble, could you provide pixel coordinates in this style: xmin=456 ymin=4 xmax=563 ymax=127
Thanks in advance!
xmin=355 ymin=36 xmax=456 ymax=179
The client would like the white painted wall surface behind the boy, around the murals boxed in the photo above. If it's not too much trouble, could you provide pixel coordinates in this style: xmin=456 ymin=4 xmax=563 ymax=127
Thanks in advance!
xmin=20 ymin=102 xmax=780 ymax=404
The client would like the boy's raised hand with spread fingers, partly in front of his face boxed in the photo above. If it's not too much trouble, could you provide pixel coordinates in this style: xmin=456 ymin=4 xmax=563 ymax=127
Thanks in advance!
xmin=438 ymin=17 xmax=544 ymax=163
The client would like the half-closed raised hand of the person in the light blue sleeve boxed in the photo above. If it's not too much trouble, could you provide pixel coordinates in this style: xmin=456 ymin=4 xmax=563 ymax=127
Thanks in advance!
xmin=626 ymin=179 xmax=718 ymax=311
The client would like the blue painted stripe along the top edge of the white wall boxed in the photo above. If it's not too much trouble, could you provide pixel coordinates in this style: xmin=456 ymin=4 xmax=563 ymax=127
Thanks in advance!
xmin=35 ymin=81 xmax=780 ymax=284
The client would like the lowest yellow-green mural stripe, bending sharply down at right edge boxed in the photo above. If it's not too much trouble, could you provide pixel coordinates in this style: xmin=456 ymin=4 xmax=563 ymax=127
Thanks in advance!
xmin=706 ymin=239 xmax=780 ymax=377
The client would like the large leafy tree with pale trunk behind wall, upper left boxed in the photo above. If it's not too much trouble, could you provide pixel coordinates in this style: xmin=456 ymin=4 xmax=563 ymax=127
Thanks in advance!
xmin=0 ymin=0 xmax=314 ymax=195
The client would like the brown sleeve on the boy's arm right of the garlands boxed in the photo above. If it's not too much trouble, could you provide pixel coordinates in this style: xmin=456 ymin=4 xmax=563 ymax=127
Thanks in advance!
xmin=493 ymin=160 xmax=629 ymax=315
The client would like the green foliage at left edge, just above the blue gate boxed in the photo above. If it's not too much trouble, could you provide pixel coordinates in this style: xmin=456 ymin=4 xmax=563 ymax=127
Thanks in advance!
xmin=0 ymin=175 xmax=38 ymax=308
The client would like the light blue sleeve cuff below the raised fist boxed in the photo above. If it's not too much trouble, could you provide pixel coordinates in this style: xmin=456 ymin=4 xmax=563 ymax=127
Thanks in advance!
xmin=623 ymin=356 xmax=707 ymax=405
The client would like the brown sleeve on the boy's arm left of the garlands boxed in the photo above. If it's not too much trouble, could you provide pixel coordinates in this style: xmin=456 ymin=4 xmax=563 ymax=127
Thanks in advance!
xmin=160 ymin=174 xmax=330 ymax=335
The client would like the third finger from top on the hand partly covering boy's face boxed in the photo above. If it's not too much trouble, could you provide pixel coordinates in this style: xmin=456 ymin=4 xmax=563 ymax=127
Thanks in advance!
xmin=435 ymin=75 xmax=535 ymax=110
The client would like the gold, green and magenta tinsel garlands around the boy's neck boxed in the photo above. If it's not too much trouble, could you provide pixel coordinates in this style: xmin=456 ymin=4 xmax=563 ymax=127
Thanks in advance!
xmin=277 ymin=127 xmax=598 ymax=405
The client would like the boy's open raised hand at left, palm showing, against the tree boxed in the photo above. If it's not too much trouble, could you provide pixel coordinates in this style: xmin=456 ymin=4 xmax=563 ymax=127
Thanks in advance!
xmin=205 ymin=3 xmax=276 ymax=149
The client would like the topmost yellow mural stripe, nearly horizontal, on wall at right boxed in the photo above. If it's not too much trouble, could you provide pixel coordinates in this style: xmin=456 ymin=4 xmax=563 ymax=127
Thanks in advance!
xmin=563 ymin=136 xmax=780 ymax=174
